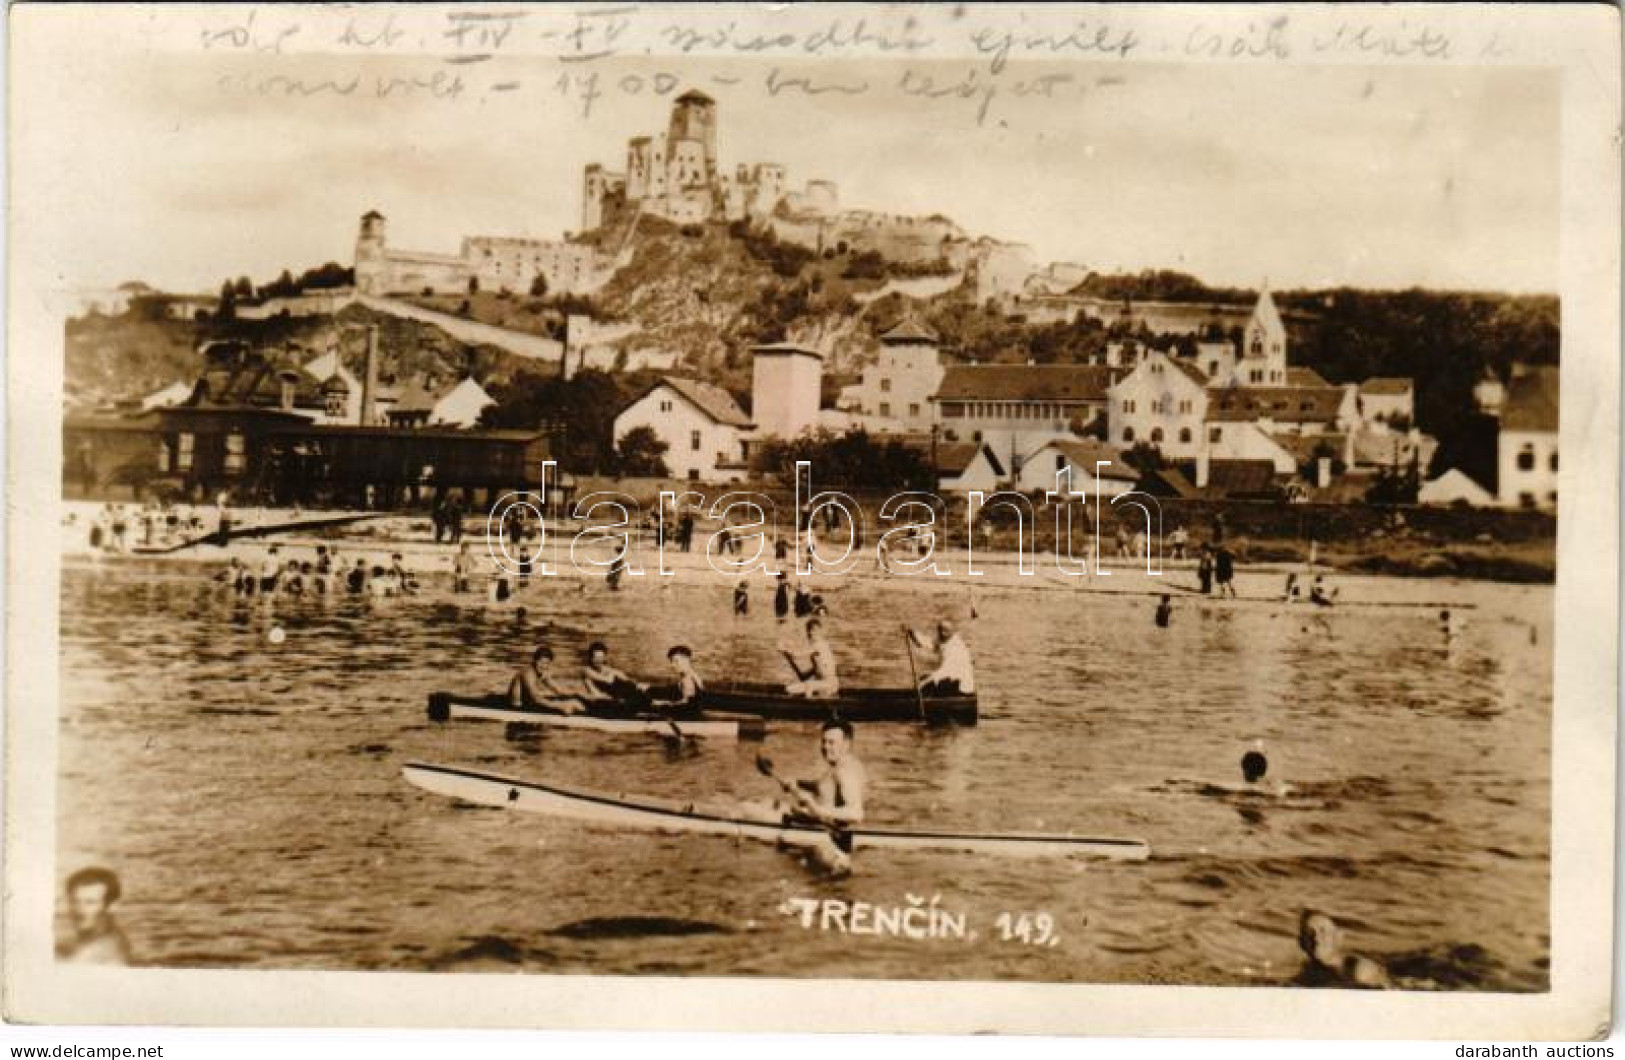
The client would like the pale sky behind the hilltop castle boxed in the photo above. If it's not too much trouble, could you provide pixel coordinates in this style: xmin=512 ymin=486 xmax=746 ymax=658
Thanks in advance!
xmin=19 ymin=39 xmax=1560 ymax=291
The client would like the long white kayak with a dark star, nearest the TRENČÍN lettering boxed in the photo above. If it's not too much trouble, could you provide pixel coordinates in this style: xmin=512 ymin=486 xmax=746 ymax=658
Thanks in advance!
xmin=401 ymin=762 xmax=1151 ymax=862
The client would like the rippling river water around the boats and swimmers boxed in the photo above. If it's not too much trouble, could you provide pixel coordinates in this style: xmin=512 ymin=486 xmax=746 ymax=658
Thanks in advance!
xmin=59 ymin=561 xmax=1552 ymax=990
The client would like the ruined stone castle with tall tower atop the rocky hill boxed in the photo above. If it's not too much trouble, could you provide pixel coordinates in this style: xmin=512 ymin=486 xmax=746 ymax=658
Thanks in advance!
xmin=582 ymin=89 xmax=839 ymax=231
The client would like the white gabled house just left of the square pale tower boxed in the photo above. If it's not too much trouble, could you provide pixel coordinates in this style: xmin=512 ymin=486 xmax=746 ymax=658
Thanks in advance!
xmin=614 ymin=376 xmax=754 ymax=481
